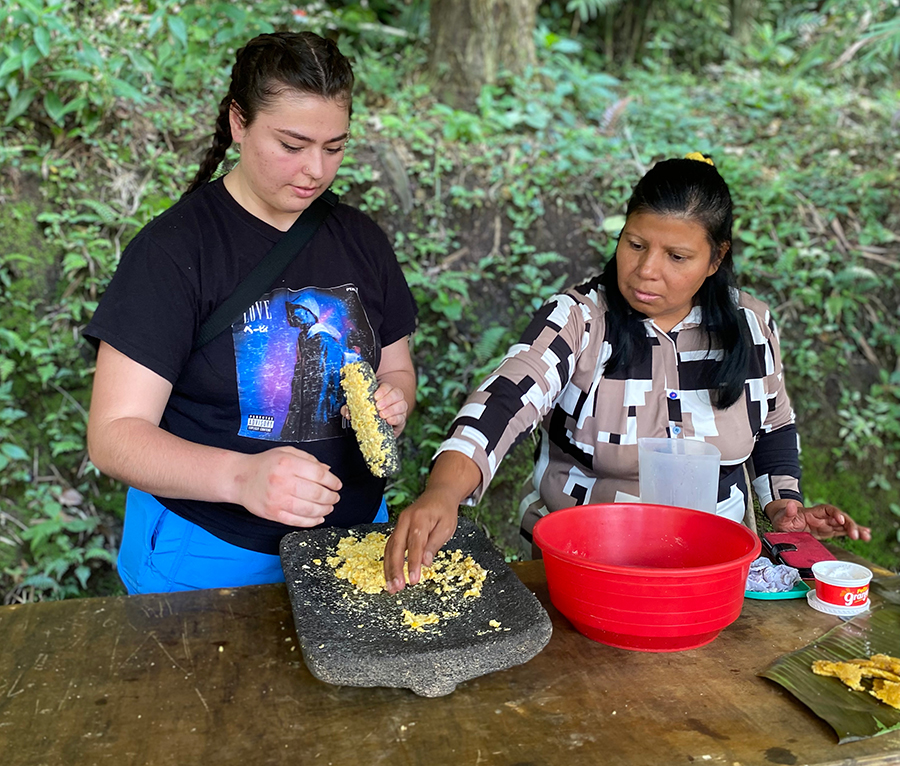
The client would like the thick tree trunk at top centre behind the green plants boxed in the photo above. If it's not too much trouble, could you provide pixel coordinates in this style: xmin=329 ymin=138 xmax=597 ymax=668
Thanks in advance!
xmin=428 ymin=0 xmax=540 ymax=108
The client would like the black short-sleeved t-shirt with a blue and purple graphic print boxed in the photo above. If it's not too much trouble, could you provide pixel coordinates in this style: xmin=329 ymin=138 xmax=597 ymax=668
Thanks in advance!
xmin=84 ymin=179 xmax=416 ymax=553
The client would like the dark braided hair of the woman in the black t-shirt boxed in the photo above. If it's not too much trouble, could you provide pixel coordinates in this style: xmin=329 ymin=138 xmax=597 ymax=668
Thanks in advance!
xmin=185 ymin=32 xmax=353 ymax=194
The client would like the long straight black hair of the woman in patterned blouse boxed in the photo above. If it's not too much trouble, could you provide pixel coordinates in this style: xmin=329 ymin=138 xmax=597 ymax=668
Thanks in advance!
xmin=600 ymin=159 xmax=750 ymax=409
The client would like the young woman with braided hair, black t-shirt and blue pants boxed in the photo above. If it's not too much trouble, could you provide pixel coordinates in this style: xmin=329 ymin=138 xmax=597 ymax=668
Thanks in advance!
xmin=85 ymin=32 xmax=416 ymax=593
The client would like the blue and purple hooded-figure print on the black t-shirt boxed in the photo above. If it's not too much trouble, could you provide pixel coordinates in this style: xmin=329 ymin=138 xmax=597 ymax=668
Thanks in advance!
xmin=231 ymin=285 xmax=375 ymax=442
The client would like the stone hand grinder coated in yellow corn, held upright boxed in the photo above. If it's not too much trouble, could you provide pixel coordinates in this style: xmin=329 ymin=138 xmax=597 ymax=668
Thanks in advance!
xmin=341 ymin=362 xmax=400 ymax=478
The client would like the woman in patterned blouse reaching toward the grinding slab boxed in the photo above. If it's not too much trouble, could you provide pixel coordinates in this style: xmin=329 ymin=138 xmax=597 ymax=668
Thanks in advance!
xmin=385 ymin=153 xmax=871 ymax=592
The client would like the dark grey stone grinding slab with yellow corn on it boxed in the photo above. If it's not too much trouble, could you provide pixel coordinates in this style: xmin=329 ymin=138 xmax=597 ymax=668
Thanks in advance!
xmin=281 ymin=518 xmax=553 ymax=697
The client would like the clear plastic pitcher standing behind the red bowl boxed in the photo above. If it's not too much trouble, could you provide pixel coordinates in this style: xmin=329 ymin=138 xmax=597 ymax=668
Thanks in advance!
xmin=638 ymin=437 xmax=721 ymax=513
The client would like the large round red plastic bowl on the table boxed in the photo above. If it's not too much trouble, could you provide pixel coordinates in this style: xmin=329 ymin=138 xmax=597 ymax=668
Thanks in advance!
xmin=534 ymin=503 xmax=761 ymax=652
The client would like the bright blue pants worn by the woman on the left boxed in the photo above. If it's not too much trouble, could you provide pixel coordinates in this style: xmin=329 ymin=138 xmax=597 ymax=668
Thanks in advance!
xmin=118 ymin=489 xmax=388 ymax=595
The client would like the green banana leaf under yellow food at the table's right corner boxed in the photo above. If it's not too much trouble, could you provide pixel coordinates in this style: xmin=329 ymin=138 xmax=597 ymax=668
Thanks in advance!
xmin=758 ymin=576 xmax=900 ymax=744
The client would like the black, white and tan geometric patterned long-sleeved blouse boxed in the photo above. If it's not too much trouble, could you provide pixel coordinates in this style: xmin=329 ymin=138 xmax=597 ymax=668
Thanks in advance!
xmin=437 ymin=278 xmax=803 ymax=541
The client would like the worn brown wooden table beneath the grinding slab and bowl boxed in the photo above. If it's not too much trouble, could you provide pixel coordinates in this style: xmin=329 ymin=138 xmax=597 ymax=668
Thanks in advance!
xmin=0 ymin=562 xmax=900 ymax=766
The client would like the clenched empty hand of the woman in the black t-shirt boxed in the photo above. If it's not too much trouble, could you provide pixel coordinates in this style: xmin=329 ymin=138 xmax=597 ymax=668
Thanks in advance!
xmin=234 ymin=447 xmax=341 ymax=527
